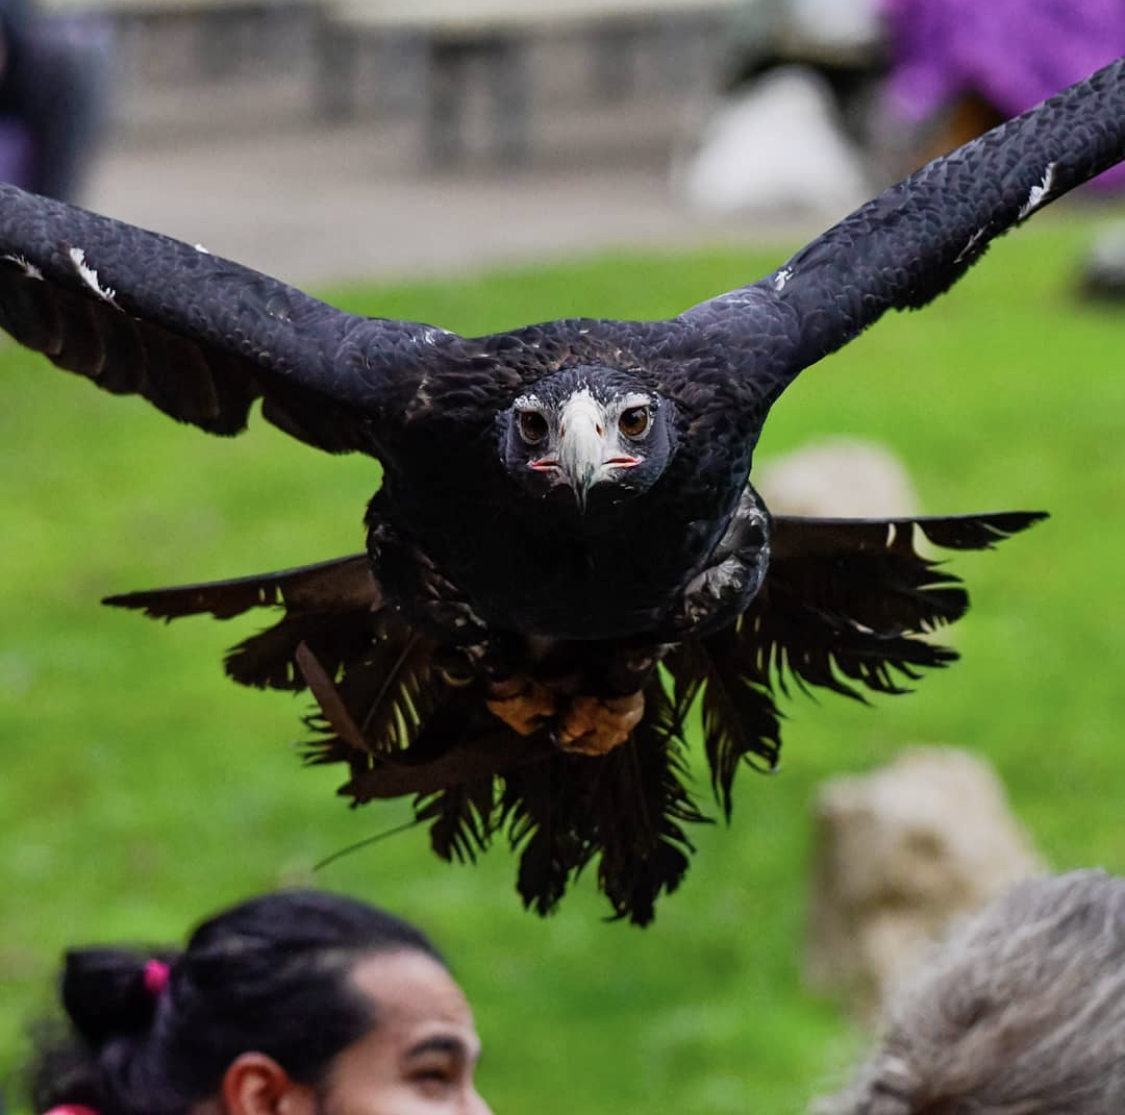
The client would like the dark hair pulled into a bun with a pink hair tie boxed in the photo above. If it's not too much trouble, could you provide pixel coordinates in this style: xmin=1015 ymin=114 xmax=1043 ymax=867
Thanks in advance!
xmin=24 ymin=890 xmax=444 ymax=1115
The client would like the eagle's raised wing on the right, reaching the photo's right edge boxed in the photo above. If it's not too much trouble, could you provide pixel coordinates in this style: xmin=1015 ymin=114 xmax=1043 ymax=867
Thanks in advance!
xmin=678 ymin=53 xmax=1125 ymax=402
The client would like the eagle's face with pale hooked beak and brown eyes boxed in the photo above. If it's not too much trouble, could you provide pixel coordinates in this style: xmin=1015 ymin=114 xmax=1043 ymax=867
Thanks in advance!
xmin=501 ymin=368 xmax=675 ymax=511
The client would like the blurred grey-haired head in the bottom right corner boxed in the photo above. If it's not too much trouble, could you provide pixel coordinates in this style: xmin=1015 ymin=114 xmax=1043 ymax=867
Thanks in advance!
xmin=816 ymin=871 xmax=1125 ymax=1115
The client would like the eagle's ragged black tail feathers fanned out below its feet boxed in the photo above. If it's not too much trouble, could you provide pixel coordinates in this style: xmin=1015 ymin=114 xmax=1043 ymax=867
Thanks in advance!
xmin=337 ymin=678 xmax=707 ymax=925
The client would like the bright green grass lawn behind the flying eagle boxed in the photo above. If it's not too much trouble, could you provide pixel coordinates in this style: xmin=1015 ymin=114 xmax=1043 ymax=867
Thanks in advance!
xmin=0 ymin=213 xmax=1125 ymax=1115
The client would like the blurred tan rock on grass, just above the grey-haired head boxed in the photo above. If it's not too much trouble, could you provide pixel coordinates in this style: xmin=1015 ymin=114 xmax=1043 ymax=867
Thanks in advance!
xmin=804 ymin=747 xmax=1043 ymax=1023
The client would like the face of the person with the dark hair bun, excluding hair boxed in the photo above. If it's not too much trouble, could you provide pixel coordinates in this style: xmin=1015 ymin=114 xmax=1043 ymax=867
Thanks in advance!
xmin=322 ymin=951 xmax=489 ymax=1115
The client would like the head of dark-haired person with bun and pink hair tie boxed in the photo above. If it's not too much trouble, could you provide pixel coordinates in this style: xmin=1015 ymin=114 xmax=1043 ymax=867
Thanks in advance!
xmin=32 ymin=891 xmax=488 ymax=1115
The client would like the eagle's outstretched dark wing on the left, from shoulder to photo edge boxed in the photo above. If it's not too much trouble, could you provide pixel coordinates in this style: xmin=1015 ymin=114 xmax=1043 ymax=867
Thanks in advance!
xmin=0 ymin=186 xmax=460 ymax=452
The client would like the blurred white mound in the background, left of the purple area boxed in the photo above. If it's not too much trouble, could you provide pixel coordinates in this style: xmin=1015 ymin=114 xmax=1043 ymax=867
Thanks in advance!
xmin=678 ymin=66 xmax=871 ymax=217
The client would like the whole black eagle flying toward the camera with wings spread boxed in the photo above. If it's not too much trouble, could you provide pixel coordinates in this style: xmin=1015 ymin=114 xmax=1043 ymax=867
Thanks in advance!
xmin=0 ymin=54 xmax=1125 ymax=924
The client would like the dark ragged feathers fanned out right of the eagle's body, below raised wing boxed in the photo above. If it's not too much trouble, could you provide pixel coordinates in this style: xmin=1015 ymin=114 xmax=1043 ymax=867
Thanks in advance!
xmin=664 ymin=511 xmax=1045 ymax=815
